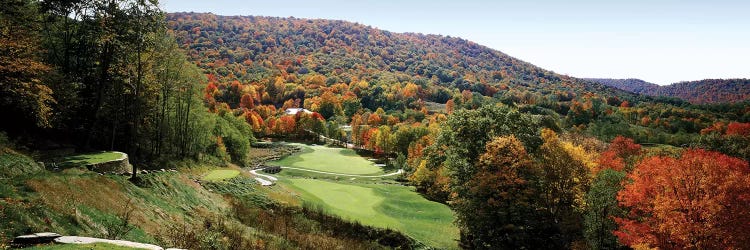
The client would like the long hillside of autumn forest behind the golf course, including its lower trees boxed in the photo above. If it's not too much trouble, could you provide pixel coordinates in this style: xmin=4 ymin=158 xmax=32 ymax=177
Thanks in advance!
xmin=167 ymin=13 xmax=748 ymax=146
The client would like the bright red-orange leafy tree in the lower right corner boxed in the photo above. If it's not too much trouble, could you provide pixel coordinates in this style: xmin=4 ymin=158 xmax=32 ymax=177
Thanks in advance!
xmin=614 ymin=149 xmax=750 ymax=249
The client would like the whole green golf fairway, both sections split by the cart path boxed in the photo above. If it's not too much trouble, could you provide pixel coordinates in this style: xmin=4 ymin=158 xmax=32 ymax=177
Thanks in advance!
xmin=268 ymin=143 xmax=458 ymax=249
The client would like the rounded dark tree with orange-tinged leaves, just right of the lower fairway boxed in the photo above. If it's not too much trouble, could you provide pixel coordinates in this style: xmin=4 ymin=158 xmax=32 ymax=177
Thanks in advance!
xmin=452 ymin=136 xmax=540 ymax=249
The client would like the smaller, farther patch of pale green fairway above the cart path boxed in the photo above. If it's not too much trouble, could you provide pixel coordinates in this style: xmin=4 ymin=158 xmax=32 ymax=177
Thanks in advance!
xmin=268 ymin=143 xmax=383 ymax=175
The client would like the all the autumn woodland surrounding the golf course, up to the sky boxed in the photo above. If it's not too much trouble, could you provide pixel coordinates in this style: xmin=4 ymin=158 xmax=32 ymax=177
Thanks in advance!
xmin=0 ymin=0 xmax=750 ymax=249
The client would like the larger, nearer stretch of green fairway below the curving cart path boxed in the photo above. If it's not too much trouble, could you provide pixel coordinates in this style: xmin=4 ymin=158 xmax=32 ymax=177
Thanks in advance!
xmin=280 ymin=178 xmax=458 ymax=248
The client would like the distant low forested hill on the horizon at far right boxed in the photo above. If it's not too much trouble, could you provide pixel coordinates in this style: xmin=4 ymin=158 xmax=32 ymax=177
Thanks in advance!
xmin=588 ymin=78 xmax=750 ymax=103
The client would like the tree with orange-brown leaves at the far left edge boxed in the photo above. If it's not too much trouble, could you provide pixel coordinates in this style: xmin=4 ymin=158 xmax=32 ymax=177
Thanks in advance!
xmin=0 ymin=0 xmax=55 ymax=129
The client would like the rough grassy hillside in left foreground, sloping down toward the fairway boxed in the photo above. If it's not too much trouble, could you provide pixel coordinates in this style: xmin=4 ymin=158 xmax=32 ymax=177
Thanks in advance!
xmin=0 ymin=142 xmax=420 ymax=249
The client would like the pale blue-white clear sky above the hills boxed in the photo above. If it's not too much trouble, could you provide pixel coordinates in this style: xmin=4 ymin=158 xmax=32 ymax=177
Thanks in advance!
xmin=161 ymin=0 xmax=750 ymax=85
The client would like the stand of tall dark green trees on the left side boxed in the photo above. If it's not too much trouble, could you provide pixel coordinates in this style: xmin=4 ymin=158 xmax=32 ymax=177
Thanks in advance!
xmin=0 ymin=0 xmax=253 ymax=174
